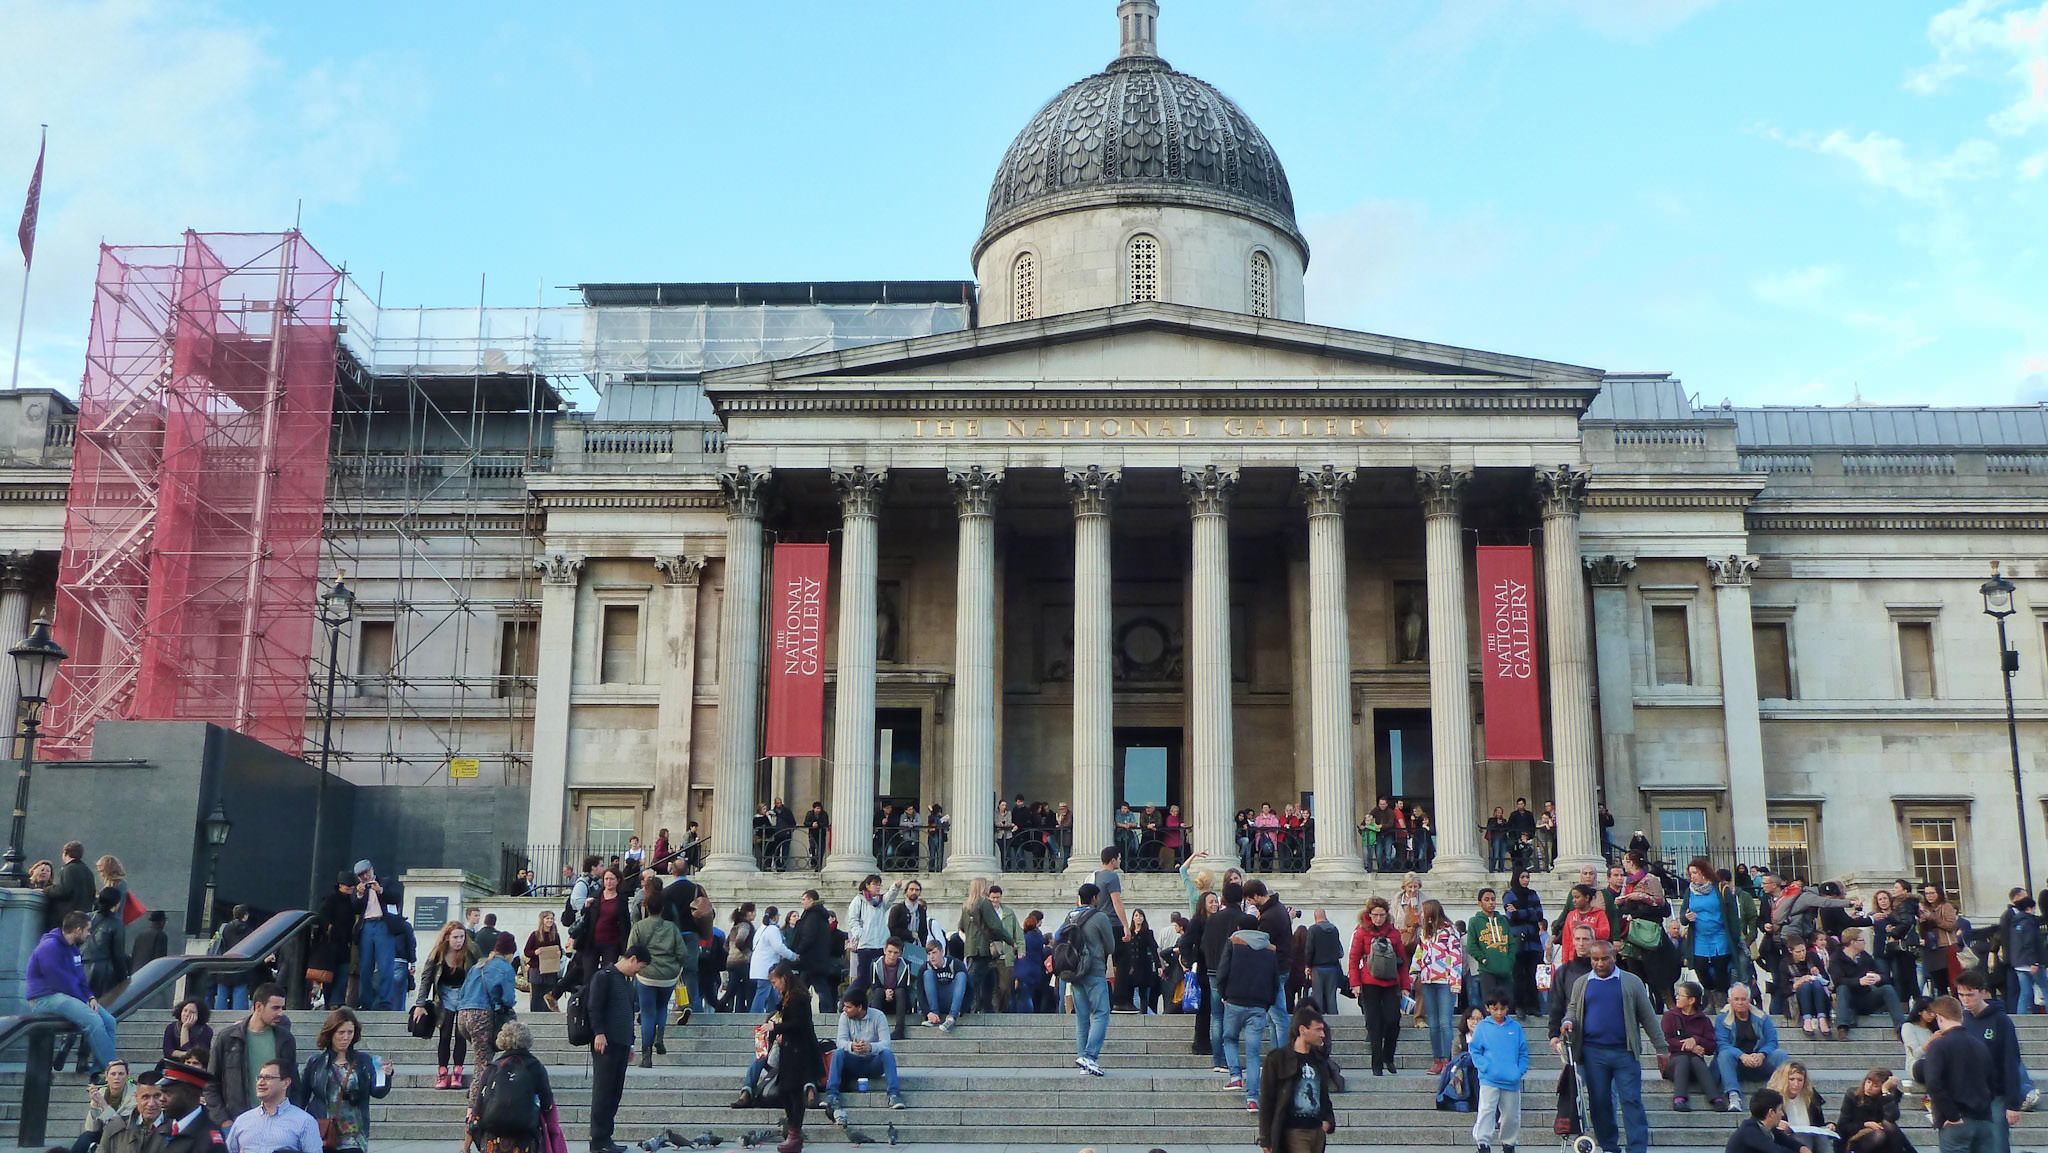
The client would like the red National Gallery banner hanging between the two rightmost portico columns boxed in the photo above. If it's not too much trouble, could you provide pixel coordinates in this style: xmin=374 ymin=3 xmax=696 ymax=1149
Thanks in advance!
xmin=1479 ymin=545 xmax=1544 ymax=760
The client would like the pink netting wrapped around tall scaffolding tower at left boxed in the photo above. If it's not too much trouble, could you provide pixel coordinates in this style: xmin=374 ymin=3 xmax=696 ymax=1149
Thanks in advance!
xmin=39 ymin=231 xmax=342 ymax=758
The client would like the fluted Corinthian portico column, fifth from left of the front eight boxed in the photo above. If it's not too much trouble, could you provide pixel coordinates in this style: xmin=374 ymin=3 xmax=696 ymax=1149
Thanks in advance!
xmin=1180 ymin=465 xmax=1237 ymax=858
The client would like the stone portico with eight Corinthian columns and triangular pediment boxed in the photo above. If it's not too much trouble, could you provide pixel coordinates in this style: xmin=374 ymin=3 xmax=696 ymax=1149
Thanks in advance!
xmin=688 ymin=303 xmax=1599 ymax=877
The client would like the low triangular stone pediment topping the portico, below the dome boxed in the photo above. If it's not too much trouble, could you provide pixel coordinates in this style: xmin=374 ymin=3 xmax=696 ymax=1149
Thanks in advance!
xmin=705 ymin=303 xmax=1602 ymax=399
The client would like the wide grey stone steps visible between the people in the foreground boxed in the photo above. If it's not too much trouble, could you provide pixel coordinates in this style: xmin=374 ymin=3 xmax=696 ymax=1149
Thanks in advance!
xmin=0 ymin=1003 xmax=2048 ymax=1151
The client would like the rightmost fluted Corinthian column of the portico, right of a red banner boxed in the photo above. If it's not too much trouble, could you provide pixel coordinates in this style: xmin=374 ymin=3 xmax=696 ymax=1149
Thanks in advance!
xmin=1536 ymin=465 xmax=1602 ymax=877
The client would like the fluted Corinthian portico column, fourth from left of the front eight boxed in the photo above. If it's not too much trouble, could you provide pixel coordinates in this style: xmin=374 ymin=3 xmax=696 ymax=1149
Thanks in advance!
xmin=1067 ymin=465 xmax=1120 ymax=872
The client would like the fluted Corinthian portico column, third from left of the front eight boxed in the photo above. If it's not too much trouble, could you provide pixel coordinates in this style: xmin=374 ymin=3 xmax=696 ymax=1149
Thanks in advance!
xmin=946 ymin=465 xmax=1004 ymax=877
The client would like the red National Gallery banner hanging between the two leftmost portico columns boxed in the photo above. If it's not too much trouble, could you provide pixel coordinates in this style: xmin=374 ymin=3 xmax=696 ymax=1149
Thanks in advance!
xmin=762 ymin=545 xmax=831 ymax=756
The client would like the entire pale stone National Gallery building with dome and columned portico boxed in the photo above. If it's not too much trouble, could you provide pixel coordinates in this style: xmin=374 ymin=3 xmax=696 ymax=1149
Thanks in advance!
xmin=0 ymin=0 xmax=2048 ymax=911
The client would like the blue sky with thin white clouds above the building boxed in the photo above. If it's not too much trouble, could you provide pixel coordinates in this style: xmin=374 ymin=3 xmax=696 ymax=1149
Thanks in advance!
xmin=0 ymin=0 xmax=2048 ymax=403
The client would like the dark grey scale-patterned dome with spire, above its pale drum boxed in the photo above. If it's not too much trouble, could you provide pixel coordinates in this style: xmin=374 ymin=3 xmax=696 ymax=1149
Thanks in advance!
xmin=975 ymin=0 xmax=1309 ymax=258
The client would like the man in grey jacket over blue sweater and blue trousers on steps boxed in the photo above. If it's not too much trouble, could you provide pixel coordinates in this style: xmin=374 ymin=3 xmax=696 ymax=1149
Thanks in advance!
xmin=1565 ymin=940 xmax=1665 ymax=1153
